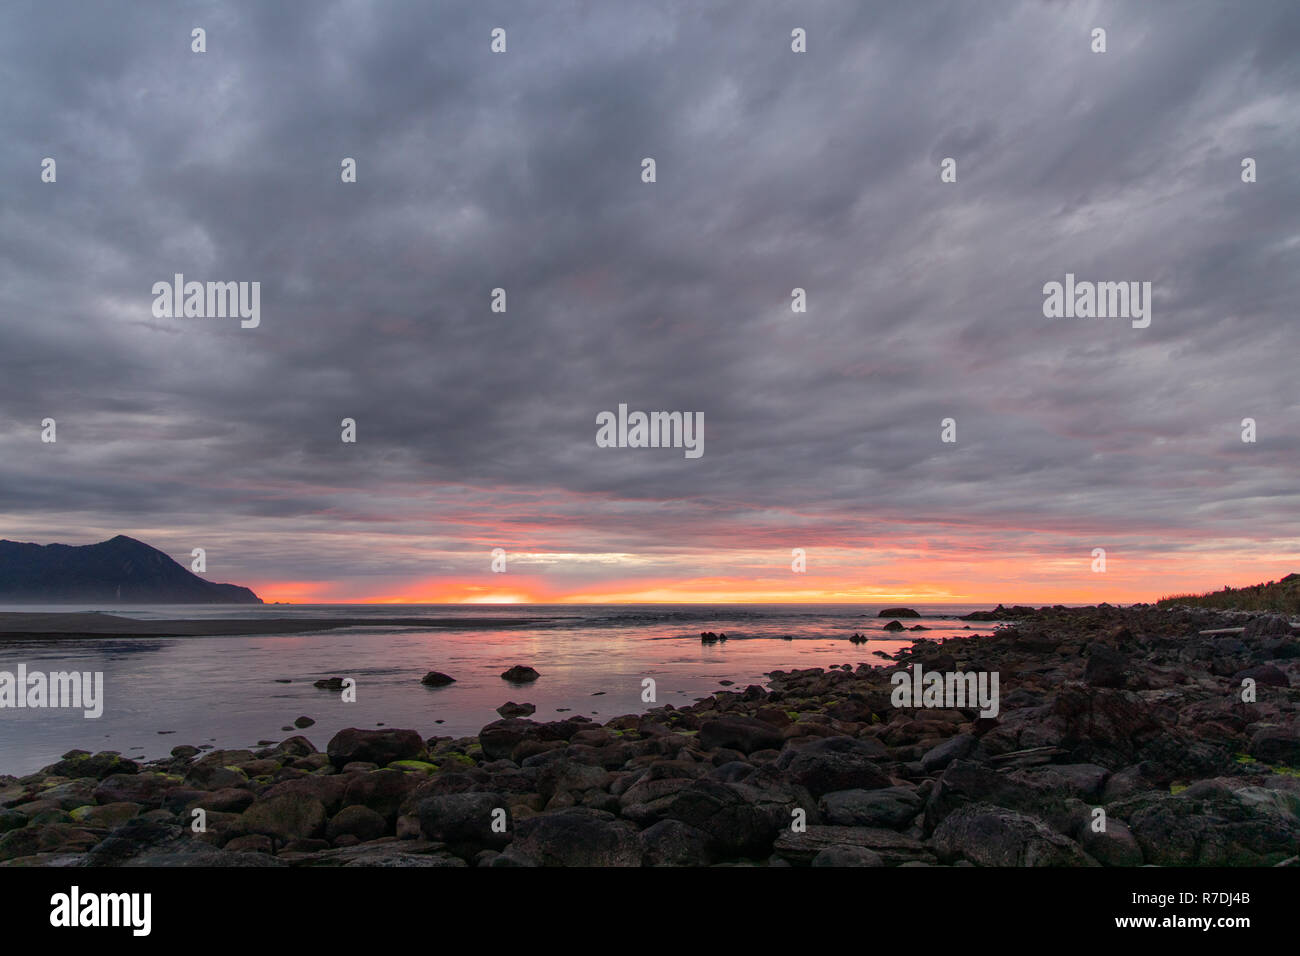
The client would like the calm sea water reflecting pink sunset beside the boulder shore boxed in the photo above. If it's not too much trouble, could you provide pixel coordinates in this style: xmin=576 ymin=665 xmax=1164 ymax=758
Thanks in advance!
xmin=0 ymin=605 xmax=993 ymax=775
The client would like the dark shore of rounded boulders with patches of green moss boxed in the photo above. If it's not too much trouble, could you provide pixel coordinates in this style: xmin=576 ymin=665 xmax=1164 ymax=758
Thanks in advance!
xmin=0 ymin=605 xmax=1300 ymax=866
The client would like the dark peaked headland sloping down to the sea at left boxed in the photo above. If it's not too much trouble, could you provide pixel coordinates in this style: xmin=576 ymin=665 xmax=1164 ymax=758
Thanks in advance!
xmin=0 ymin=535 xmax=261 ymax=604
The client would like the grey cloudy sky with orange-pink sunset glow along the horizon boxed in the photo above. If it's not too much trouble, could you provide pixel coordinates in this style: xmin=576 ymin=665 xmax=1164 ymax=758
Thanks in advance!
xmin=0 ymin=0 xmax=1300 ymax=604
